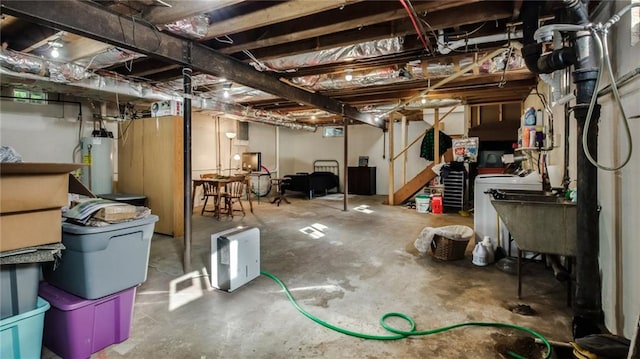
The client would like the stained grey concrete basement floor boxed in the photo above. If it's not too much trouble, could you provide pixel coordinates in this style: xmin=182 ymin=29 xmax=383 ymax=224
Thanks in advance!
xmin=43 ymin=196 xmax=571 ymax=359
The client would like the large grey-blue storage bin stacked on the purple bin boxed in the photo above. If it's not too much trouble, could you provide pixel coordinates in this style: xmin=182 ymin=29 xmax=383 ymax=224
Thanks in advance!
xmin=43 ymin=215 xmax=158 ymax=299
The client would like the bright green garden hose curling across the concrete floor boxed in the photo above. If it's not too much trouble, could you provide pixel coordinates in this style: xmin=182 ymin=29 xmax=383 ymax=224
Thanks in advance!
xmin=260 ymin=271 xmax=551 ymax=359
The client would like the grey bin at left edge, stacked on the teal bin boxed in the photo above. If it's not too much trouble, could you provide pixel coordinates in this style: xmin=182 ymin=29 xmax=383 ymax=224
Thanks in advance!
xmin=0 ymin=263 xmax=40 ymax=319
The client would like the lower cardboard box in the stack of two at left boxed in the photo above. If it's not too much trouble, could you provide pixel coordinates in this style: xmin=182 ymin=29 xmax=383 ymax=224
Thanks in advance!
xmin=0 ymin=208 xmax=62 ymax=252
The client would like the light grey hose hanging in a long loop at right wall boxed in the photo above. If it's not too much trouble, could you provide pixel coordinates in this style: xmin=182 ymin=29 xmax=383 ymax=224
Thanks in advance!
xmin=582 ymin=7 xmax=640 ymax=171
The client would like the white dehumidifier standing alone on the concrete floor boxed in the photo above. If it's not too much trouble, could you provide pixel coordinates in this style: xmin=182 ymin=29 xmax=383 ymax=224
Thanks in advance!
xmin=210 ymin=227 xmax=260 ymax=292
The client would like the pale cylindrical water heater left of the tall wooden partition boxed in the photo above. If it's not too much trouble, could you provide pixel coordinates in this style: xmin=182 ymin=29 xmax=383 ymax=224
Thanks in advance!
xmin=80 ymin=137 xmax=113 ymax=195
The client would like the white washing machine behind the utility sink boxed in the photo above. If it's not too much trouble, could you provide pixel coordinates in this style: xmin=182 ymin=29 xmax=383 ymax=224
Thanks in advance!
xmin=473 ymin=172 xmax=542 ymax=255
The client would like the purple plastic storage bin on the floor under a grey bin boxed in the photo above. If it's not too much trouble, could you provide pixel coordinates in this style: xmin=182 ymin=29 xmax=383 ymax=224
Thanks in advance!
xmin=38 ymin=282 xmax=136 ymax=359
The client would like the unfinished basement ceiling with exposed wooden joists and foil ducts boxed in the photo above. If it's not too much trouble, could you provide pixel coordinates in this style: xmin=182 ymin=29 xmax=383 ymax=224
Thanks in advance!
xmin=0 ymin=0 xmax=552 ymax=127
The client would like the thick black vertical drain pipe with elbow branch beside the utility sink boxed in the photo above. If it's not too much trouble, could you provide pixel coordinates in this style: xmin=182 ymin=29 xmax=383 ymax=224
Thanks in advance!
xmin=521 ymin=0 xmax=603 ymax=338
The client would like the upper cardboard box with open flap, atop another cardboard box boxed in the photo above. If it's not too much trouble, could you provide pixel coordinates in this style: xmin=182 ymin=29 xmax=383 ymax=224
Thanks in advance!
xmin=0 ymin=162 xmax=82 ymax=214
